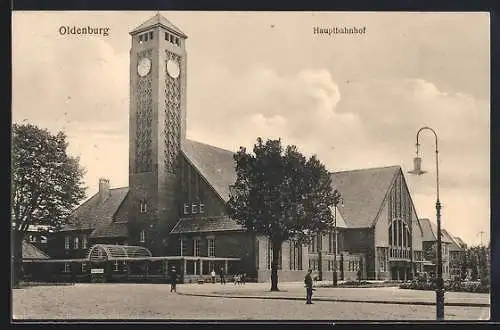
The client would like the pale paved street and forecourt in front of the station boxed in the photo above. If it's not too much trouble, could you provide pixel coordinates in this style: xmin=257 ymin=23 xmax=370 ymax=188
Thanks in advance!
xmin=13 ymin=283 xmax=489 ymax=320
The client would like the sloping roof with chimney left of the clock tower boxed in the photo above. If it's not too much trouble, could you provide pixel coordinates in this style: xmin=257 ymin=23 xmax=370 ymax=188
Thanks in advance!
xmin=62 ymin=187 xmax=128 ymax=235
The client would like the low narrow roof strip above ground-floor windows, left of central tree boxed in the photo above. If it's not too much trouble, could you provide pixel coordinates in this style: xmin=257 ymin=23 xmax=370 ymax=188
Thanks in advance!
xmin=170 ymin=216 xmax=244 ymax=234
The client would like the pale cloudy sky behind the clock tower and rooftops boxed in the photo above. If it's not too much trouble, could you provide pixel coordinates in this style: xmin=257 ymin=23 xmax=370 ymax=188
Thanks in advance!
xmin=12 ymin=11 xmax=490 ymax=248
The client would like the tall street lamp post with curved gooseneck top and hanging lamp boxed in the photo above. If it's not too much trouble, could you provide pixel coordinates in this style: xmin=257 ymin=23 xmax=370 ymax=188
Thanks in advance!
xmin=408 ymin=126 xmax=444 ymax=320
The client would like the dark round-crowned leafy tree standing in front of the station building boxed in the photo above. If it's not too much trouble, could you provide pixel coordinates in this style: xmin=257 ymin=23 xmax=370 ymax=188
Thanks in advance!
xmin=227 ymin=138 xmax=334 ymax=291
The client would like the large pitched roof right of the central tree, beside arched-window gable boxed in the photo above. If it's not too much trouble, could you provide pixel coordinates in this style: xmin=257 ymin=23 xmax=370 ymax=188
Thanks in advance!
xmin=331 ymin=166 xmax=401 ymax=228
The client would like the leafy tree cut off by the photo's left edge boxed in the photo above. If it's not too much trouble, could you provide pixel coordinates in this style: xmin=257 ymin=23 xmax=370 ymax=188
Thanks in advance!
xmin=11 ymin=124 xmax=85 ymax=284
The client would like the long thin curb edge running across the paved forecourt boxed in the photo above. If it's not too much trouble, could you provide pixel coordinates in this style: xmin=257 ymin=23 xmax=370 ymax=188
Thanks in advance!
xmin=177 ymin=292 xmax=490 ymax=307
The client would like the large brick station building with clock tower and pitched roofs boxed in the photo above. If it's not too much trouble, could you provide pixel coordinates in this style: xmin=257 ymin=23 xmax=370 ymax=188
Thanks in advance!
xmin=20 ymin=14 xmax=464 ymax=282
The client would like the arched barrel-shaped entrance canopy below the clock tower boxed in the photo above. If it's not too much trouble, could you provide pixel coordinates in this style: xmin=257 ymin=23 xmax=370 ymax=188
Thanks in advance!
xmin=88 ymin=244 xmax=152 ymax=262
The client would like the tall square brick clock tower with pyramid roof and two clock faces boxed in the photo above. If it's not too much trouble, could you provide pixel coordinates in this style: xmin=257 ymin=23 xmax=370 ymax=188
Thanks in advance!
xmin=127 ymin=13 xmax=187 ymax=255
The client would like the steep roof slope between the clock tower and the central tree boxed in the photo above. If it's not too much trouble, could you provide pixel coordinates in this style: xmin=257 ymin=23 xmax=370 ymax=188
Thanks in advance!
xmin=182 ymin=140 xmax=236 ymax=201
